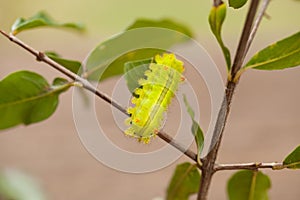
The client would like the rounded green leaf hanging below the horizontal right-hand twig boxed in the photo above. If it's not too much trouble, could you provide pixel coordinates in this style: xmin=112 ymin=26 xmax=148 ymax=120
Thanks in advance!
xmin=227 ymin=170 xmax=271 ymax=200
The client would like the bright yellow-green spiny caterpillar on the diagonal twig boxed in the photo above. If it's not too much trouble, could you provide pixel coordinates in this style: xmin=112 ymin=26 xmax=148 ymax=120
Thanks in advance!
xmin=125 ymin=54 xmax=184 ymax=143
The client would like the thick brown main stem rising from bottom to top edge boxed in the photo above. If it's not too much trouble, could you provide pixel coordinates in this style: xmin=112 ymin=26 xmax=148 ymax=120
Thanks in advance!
xmin=197 ymin=0 xmax=259 ymax=200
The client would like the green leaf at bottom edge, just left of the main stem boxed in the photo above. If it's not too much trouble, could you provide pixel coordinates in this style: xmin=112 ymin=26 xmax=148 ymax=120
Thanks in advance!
xmin=167 ymin=163 xmax=201 ymax=200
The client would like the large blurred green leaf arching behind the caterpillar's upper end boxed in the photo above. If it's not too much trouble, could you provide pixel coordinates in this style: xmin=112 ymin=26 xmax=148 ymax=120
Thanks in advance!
xmin=84 ymin=19 xmax=191 ymax=81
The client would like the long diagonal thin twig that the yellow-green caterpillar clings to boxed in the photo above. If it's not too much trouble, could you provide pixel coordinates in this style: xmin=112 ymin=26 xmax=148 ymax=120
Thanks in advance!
xmin=0 ymin=30 xmax=197 ymax=163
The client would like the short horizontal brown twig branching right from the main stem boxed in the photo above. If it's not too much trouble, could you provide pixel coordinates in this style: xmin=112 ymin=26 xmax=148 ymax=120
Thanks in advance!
xmin=215 ymin=162 xmax=286 ymax=171
